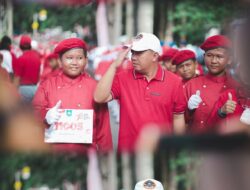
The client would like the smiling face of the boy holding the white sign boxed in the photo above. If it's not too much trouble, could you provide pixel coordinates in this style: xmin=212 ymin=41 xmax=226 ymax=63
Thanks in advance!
xmin=60 ymin=49 xmax=87 ymax=78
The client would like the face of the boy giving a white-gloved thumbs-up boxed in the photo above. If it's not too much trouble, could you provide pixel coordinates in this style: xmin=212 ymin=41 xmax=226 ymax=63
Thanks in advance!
xmin=204 ymin=48 xmax=231 ymax=76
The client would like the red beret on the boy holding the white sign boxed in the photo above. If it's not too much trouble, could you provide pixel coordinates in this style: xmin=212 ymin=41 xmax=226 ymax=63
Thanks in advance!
xmin=54 ymin=38 xmax=87 ymax=54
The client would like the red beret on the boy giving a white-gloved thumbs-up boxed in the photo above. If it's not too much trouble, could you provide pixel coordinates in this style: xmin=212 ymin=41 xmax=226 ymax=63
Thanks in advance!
xmin=200 ymin=35 xmax=232 ymax=51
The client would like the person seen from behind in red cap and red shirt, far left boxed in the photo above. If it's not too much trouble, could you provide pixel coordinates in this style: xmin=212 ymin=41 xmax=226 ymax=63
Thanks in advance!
xmin=14 ymin=35 xmax=41 ymax=102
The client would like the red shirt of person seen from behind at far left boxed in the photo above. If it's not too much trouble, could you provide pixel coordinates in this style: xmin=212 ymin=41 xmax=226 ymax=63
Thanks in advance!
xmin=15 ymin=50 xmax=41 ymax=85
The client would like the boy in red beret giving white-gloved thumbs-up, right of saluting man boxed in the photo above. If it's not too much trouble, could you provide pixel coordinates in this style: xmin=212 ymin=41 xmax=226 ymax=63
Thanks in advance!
xmin=185 ymin=35 xmax=236 ymax=133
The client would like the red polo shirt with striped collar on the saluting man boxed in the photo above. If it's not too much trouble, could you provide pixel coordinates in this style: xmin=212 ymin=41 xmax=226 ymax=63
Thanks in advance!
xmin=112 ymin=65 xmax=186 ymax=151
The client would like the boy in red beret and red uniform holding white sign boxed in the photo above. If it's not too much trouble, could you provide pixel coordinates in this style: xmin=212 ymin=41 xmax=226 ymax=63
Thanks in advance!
xmin=33 ymin=38 xmax=112 ymax=153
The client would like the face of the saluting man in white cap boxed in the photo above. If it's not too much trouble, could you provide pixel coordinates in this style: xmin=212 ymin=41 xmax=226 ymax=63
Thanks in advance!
xmin=131 ymin=50 xmax=158 ymax=74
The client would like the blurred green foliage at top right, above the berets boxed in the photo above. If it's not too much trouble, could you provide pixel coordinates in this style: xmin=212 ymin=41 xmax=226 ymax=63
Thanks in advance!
xmin=171 ymin=0 xmax=239 ymax=44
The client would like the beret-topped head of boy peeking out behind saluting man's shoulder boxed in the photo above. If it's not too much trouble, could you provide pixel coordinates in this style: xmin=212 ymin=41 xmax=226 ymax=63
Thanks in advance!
xmin=173 ymin=50 xmax=198 ymax=84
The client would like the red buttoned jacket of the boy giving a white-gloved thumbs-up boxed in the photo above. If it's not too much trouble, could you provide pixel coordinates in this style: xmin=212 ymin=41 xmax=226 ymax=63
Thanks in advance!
xmin=185 ymin=74 xmax=237 ymax=133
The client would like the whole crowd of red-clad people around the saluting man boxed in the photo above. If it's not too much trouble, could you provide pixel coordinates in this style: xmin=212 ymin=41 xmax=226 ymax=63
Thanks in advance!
xmin=0 ymin=33 xmax=250 ymax=156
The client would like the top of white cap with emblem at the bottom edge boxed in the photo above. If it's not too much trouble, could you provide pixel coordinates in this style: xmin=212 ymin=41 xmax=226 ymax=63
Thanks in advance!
xmin=134 ymin=179 xmax=164 ymax=190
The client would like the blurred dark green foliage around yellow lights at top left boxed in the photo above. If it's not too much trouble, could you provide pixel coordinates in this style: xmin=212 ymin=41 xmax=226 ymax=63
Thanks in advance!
xmin=14 ymin=3 xmax=96 ymax=38
